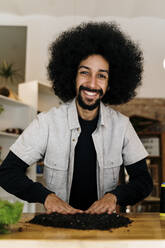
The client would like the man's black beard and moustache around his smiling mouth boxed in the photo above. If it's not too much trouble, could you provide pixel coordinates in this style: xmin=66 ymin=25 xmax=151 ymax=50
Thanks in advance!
xmin=77 ymin=85 xmax=103 ymax=111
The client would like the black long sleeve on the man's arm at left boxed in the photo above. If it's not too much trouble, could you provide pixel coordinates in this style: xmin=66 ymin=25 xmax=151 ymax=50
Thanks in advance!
xmin=0 ymin=152 xmax=52 ymax=203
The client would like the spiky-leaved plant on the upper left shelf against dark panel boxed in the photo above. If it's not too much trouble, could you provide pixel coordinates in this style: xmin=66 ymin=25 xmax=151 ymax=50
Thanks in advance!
xmin=0 ymin=60 xmax=22 ymax=83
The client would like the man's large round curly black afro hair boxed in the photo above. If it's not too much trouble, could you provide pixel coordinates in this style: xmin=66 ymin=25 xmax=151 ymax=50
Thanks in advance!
xmin=47 ymin=22 xmax=143 ymax=105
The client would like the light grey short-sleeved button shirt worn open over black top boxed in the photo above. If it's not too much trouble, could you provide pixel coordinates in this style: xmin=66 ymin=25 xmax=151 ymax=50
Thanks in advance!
xmin=10 ymin=99 xmax=148 ymax=202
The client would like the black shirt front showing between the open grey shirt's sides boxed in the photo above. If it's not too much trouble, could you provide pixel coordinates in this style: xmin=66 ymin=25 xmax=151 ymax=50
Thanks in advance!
xmin=69 ymin=116 xmax=98 ymax=210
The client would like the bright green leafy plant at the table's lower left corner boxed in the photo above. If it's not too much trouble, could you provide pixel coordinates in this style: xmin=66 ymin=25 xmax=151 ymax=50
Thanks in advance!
xmin=0 ymin=200 xmax=23 ymax=233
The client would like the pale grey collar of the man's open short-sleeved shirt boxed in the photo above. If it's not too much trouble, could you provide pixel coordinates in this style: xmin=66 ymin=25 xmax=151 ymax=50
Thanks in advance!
xmin=68 ymin=98 xmax=106 ymax=129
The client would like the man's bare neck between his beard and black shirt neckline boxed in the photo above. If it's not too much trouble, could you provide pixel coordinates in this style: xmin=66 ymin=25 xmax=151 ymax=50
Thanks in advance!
xmin=76 ymin=101 xmax=99 ymax=121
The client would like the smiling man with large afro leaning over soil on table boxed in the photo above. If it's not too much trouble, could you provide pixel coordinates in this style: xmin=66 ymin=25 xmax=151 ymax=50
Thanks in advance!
xmin=0 ymin=22 xmax=152 ymax=214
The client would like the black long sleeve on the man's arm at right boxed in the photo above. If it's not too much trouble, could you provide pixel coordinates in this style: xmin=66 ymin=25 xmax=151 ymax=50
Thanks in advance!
xmin=109 ymin=159 xmax=153 ymax=206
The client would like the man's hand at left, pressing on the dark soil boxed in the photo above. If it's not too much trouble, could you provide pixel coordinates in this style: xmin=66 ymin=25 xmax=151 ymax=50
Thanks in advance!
xmin=44 ymin=193 xmax=83 ymax=214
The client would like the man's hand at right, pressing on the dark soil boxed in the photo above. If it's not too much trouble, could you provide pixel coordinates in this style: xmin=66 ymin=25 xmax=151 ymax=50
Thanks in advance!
xmin=85 ymin=193 xmax=117 ymax=214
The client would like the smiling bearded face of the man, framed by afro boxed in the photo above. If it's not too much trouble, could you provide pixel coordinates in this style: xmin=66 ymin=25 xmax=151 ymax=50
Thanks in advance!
xmin=76 ymin=55 xmax=109 ymax=110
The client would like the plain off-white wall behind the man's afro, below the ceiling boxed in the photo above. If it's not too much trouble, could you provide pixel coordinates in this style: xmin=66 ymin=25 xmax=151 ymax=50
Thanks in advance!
xmin=0 ymin=15 xmax=165 ymax=98
